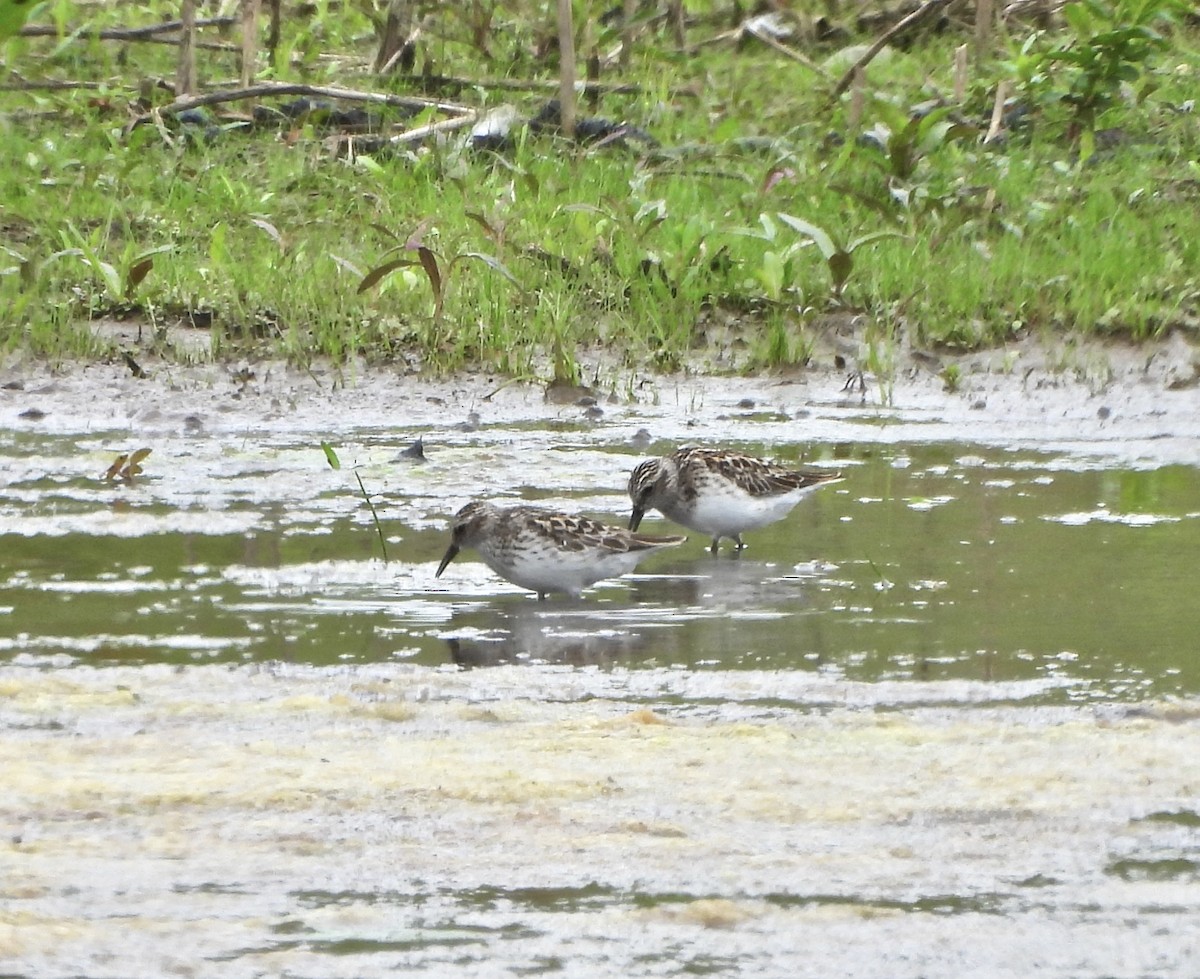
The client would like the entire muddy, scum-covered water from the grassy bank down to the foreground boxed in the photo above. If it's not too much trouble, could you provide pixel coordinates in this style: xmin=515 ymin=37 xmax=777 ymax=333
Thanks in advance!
xmin=0 ymin=362 xmax=1200 ymax=977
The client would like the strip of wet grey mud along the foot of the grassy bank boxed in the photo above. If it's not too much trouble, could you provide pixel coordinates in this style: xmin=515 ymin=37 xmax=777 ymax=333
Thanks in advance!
xmin=0 ymin=334 xmax=1200 ymax=463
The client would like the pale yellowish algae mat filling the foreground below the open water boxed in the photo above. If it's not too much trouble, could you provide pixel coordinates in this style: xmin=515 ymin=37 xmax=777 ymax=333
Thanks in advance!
xmin=0 ymin=663 xmax=1200 ymax=977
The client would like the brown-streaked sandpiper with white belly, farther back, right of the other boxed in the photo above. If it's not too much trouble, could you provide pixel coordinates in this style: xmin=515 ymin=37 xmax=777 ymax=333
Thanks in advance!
xmin=629 ymin=446 xmax=842 ymax=554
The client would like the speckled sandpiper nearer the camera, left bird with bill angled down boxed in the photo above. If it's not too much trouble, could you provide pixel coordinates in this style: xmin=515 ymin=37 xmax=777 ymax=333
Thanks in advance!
xmin=434 ymin=500 xmax=688 ymax=599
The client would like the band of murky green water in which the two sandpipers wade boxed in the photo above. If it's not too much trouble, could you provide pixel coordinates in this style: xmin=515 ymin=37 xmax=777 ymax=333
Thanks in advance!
xmin=0 ymin=443 xmax=1200 ymax=699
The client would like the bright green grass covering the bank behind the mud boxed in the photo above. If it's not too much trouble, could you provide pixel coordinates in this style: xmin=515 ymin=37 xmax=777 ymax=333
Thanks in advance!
xmin=0 ymin=4 xmax=1200 ymax=379
